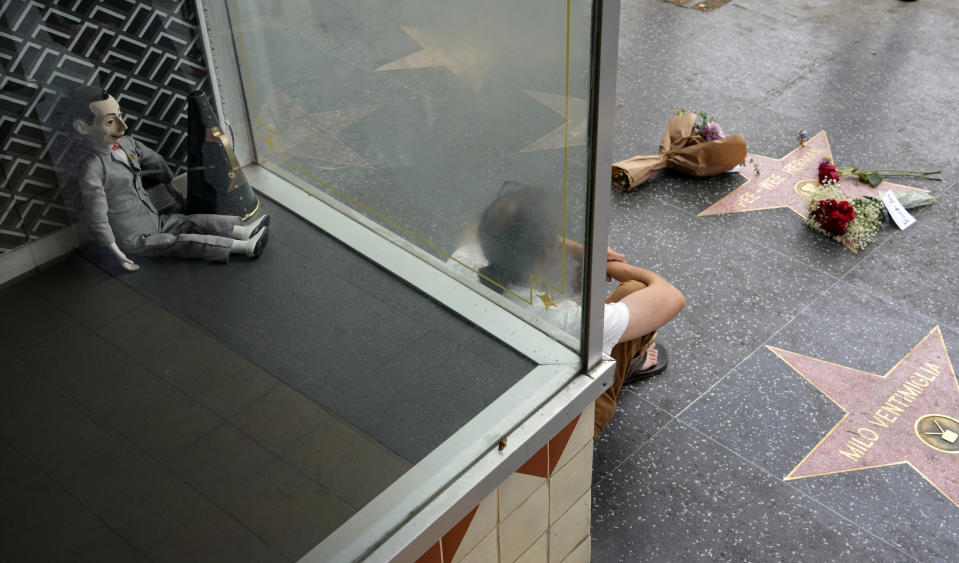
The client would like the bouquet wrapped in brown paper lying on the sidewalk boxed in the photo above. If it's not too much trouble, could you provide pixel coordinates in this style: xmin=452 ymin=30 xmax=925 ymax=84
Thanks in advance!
xmin=613 ymin=110 xmax=746 ymax=191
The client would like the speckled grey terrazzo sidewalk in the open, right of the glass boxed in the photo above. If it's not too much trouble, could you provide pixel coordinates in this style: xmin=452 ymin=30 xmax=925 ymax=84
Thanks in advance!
xmin=592 ymin=0 xmax=959 ymax=562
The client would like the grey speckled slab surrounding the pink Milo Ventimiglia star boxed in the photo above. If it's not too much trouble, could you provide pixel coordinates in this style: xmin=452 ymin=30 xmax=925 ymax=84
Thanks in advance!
xmin=679 ymin=283 xmax=959 ymax=560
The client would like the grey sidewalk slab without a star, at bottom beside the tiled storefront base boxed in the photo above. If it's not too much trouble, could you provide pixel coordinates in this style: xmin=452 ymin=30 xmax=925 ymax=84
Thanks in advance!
xmin=592 ymin=421 xmax=905 ymax=562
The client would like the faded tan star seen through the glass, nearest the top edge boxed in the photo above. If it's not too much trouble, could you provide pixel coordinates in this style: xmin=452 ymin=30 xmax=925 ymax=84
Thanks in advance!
xmin=374 ymin=25 xmax=493 ymax=92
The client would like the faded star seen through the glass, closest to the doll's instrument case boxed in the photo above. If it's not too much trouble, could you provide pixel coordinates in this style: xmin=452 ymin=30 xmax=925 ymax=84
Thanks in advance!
xmin=257 ymin=88 xmax=381 ymax=168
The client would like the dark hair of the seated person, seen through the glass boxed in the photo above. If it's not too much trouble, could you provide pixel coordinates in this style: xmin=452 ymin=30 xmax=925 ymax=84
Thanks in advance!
xmin=477 ymin=182 xmax=559 ymax=293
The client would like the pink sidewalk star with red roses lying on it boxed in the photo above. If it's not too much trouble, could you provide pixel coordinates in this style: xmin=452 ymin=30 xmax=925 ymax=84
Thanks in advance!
xmin=699 ymin=131 xmax=927 ymax=236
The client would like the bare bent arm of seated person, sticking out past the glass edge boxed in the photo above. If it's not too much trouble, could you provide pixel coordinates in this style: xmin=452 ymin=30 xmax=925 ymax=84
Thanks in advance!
xmin=606 ymin=260 xmax=686 ymax=342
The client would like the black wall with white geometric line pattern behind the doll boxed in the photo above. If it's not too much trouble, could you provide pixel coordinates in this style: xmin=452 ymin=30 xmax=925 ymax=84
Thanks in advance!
xmin=0 ymin=0 xmax=209 ymax=253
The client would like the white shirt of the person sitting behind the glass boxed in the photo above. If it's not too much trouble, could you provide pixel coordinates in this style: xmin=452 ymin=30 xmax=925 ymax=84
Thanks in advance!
xmin=447 ymin=240 xmax=629 ymax=354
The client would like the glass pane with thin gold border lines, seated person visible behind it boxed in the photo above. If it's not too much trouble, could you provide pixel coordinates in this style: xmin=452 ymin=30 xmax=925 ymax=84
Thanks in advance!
xmin=231 ymin=0 xmax=590 ymax=350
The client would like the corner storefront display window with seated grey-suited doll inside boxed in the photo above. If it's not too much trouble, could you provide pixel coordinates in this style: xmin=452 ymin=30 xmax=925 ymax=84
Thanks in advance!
xmin=0 ymin=0 xmax=601 ymax=560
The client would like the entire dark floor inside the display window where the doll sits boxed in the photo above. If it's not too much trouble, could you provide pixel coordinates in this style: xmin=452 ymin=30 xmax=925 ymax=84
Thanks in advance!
xmin=0 ymin=197 xmax=531 ymax=562
